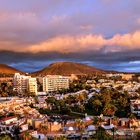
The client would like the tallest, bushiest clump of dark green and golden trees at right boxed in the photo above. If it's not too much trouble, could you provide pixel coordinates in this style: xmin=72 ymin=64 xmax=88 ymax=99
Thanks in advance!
xmin=86 ymin=88 xmax=130 ymax=117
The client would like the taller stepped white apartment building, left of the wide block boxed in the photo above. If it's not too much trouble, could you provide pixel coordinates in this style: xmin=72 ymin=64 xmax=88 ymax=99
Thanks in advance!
xmin=13 ymin=73 xmax=37 ymax=94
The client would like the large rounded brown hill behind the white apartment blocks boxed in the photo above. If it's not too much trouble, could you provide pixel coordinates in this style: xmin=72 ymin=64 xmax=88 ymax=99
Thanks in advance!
xmin=32 ymin=62 xmax=107 ymax=76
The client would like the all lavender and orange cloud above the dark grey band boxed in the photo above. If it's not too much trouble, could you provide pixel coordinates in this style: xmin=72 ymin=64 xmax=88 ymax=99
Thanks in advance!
xmin=0 ymin=0 xmax=140 ymax=53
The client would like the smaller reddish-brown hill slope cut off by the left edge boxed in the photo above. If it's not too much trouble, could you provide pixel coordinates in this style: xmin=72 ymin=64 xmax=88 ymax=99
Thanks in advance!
xmin=0 ymin=64 xmax=22 ymax=74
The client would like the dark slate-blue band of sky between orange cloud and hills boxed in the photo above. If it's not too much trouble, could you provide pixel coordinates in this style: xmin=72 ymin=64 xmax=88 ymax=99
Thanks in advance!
xmin=0 ymin=50 xmax=140 ymax=72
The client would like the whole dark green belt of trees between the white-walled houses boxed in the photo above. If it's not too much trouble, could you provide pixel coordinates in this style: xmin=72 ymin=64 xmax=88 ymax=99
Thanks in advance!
xmin=37 ymin=88 xmax=131 ymax=117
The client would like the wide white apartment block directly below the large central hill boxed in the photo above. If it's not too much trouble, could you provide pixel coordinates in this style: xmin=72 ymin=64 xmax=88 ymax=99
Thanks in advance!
xmin=43 ymin=75 xmax=70 ymax=92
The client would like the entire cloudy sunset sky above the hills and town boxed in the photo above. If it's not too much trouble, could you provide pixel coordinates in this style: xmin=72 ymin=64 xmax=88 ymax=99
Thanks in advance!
xmin=0 ymin=0 xmax=140 ymax=72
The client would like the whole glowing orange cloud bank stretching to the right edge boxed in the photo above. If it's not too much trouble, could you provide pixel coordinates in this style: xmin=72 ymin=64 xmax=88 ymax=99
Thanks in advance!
xmin=19 ymin=31 xmax=140 ymax=53
